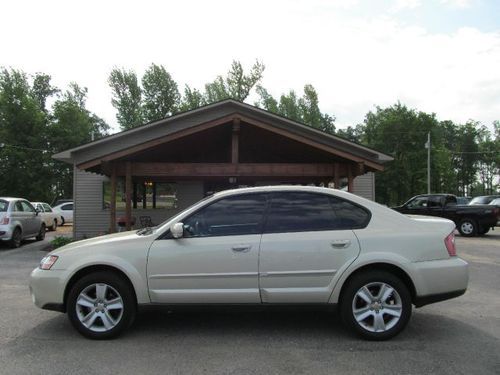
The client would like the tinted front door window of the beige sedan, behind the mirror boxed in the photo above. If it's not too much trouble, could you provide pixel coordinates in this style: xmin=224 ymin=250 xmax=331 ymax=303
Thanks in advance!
xmin=184 ymin=194 xmax=267 ymax=237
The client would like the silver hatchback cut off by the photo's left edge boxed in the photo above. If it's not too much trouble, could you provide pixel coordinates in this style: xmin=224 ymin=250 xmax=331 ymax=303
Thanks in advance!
xmin=0 ymin=198 xmax=46 ymax=247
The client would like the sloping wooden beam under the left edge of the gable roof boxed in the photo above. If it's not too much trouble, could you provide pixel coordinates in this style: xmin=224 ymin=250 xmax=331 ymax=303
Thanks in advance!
xmin=77 ymin=114 xmax=239 ymax=169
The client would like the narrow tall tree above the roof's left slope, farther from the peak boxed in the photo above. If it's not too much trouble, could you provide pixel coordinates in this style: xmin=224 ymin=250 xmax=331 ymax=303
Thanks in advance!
xmin=108 ymin=68 xmax=143 ymax=130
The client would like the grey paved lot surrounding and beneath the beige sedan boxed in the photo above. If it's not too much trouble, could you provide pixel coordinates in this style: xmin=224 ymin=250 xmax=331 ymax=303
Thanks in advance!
xmin=0 ymin=228 xmax=500 ymax=374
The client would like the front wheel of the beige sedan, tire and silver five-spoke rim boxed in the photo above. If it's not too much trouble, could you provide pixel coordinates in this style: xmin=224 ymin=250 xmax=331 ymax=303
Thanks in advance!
xmin=66 ymin=272 xmax=136 ymax=340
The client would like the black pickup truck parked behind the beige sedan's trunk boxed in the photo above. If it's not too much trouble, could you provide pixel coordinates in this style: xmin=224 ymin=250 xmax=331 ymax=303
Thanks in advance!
xmin=393 ymin=194 xmax=500 ymax=237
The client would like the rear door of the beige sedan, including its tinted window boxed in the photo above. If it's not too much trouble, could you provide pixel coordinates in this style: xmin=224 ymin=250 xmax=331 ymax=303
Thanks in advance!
xmin=259 ymin=192 xmax=360 ymax=303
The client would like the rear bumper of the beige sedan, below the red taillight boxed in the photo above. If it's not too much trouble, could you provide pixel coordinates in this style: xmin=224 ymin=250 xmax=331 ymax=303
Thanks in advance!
xmin=412 ymin=257 xmax=469 ymax=307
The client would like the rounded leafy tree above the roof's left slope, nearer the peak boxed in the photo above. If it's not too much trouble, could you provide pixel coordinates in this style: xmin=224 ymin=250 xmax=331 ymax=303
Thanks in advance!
xmin=142 ymin=64 xmax=180 ymax=121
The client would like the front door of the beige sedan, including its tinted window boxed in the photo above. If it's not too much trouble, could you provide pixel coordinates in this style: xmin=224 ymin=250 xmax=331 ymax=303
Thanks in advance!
xmin=147 ymin=194 xmax=267 ymax=304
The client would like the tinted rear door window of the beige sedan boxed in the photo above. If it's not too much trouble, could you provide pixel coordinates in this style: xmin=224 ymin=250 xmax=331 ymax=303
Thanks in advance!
xmin=265 ymin=192 xmax=335 ymax=233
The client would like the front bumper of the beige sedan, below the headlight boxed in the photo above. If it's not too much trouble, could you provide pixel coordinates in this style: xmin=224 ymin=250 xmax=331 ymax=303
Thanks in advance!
xmin=29 ymin=268 xmax=65 ymax=312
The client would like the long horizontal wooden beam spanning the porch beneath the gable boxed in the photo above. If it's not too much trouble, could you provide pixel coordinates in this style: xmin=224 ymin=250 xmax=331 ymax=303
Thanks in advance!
xmin=118 ymin=163 xmax=340 ymax=177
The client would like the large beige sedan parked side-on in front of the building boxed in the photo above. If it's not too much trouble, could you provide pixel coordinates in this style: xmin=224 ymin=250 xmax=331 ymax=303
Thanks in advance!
xmin=30 ymin=186 xmax=468 ymax=340
